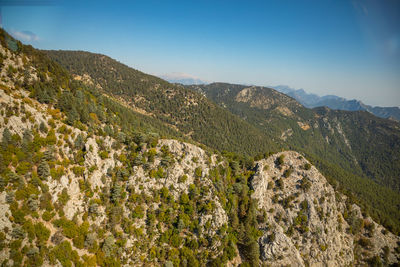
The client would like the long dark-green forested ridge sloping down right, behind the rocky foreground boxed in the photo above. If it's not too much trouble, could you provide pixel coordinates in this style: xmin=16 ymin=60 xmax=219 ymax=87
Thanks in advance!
xmin=45 ymin=51 xmax=277 ymax=155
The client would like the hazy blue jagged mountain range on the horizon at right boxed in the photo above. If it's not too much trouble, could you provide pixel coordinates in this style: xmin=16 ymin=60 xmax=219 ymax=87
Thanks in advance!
xmin=272 ymin=85 xmax=400 ymax=121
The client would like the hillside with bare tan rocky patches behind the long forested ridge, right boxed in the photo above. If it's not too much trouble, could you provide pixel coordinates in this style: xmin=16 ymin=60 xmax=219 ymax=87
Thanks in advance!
xmin=190 ymin=83 xmax=400 ymax=231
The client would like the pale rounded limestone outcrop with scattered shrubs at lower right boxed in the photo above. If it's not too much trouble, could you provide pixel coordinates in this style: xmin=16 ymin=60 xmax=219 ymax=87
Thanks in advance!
xmin=251 ymin=151 xmax=399 ymax=266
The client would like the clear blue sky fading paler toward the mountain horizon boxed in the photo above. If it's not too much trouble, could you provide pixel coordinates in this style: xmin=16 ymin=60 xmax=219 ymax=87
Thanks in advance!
xmin=0 ymin=0 xmax=400 ymax=106
